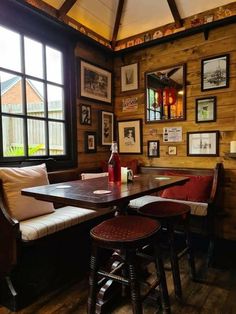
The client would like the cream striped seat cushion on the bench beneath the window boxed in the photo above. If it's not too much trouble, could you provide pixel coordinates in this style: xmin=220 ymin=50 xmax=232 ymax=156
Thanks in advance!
xmin=20 ymin=206 xmax=112 ymax=241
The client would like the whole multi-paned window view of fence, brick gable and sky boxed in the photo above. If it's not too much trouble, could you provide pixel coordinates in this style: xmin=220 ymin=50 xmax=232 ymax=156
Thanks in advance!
xmin=0 ymin=26 xmax=66 ymax=158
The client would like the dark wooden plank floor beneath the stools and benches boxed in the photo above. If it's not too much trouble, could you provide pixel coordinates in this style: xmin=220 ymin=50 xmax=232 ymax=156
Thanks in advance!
xmin=0 ymin=253 xmax=236 ymax=314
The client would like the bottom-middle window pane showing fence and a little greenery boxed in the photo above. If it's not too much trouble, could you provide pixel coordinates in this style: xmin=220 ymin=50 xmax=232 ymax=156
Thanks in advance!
xmin=27 ymin=119 xmax=46 ymax=156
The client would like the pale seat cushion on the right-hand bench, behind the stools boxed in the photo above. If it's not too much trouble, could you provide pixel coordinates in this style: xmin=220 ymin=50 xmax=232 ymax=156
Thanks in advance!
xmin=129 ymin=195 xmax=208 ymax=216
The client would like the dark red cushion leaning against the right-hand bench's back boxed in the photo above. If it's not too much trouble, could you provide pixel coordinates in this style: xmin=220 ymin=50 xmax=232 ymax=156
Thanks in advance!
xmin=161 ymin=173 xmax=213 ymax=202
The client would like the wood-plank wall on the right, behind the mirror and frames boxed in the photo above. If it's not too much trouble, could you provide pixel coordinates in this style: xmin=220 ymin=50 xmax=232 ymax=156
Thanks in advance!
xmin=114 ymin=24 xmax=236 ymax=239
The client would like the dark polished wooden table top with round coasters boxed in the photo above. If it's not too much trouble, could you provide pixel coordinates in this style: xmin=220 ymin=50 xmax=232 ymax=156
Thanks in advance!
xmin=21 ymin=174 xmax=189 ymax=208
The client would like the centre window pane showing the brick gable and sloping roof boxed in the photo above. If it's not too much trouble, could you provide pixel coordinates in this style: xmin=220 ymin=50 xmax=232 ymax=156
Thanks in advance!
xmin=26 ymin=79 xmax=45 ymax=117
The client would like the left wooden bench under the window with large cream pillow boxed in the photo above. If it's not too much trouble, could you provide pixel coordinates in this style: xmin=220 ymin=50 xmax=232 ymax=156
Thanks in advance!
xmin=0 ymin=164 xmax=112 ymax=311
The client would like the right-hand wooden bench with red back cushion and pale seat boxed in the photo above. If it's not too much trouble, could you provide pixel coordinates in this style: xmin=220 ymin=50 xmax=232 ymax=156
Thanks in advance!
xmin=129 ymin=163 xmax=223 ymax=264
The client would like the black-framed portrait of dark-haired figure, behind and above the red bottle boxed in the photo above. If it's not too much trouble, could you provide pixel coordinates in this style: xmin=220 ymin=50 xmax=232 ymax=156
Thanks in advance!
xmin=117 ymin=119 xmax=143 ymax=154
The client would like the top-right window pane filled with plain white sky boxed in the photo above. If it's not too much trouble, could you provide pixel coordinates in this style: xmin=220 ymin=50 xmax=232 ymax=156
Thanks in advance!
xmin=46 ymin=47 xmax=63 ymax=84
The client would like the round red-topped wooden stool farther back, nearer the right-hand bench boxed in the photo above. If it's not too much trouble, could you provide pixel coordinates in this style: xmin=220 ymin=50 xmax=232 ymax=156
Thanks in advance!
xmin=138 ymin=201 xmax=196 ymax=300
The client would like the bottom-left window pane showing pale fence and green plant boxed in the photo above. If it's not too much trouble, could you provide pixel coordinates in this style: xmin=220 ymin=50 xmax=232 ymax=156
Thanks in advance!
xmin=2 ymin=117 xmax=25 ymax=157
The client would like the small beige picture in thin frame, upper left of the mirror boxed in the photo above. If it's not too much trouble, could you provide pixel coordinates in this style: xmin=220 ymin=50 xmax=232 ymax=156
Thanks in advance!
xmin=121 ymin=63 xmax=138 ymax=92
